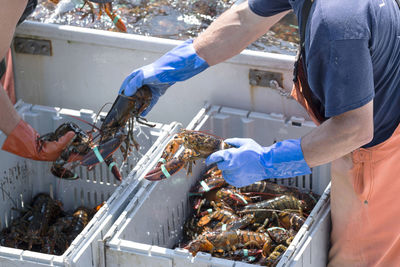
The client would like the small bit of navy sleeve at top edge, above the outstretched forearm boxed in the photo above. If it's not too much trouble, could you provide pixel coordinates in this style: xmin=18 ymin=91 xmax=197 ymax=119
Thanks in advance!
xmin=248 ymin=0 xmax=292 ymax=17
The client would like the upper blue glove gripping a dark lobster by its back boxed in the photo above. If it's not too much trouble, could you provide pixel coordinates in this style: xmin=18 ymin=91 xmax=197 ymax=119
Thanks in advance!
xmin=119 ymin=39 xmax=209 ymax=116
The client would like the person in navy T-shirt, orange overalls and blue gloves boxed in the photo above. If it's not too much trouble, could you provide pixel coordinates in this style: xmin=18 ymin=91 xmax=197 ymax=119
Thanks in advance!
xmin=120 ymin=0 xmax=400 ymax=266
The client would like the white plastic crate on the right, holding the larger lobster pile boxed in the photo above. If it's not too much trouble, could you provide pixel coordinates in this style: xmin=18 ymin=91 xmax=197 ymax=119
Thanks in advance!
xmin=105 ymin=106 xmax=330 ymax=267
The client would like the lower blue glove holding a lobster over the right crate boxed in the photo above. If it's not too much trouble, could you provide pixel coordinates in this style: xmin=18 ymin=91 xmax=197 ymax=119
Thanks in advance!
xmin=206 ymin=138 xmax=311 ymax=187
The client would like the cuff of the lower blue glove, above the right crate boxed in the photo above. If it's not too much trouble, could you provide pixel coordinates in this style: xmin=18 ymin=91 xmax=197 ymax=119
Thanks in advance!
xmin=261 ymin=139 xmax=311 ymax=178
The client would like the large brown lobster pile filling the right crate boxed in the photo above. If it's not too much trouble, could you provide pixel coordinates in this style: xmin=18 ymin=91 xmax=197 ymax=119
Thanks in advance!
xmin=181 ymin=166 xmax=319 ymax=266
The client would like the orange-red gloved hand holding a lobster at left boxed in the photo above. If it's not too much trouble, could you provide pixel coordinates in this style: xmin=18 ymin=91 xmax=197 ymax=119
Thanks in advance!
xmin=2 ymin=119 xmax=75 ymax=161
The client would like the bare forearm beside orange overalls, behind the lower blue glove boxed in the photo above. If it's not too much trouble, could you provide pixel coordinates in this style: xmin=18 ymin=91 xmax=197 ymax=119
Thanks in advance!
xmin=301 ymin=101 xmax=373 ymax=168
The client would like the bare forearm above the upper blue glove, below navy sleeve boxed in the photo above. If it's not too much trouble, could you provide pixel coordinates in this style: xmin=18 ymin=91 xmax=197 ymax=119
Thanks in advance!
xmin=193 ymin=2 xmax=287 ymax=65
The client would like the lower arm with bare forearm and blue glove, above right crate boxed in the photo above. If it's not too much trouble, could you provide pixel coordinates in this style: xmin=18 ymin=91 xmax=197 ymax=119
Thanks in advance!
xmin=206 ymin=101 xmax=374 ymax=187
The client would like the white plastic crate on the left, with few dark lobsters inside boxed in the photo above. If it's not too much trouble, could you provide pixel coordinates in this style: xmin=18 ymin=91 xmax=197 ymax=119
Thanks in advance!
xmin=0 ymin=101 xmax=179 ymax=267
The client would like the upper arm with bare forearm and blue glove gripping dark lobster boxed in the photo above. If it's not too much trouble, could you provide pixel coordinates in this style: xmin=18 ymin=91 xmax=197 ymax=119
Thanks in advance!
xmin=119 ymin=2 xmax=285 ymax=116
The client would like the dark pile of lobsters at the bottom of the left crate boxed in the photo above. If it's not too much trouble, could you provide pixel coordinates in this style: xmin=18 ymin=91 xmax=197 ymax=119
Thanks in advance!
xmin=0 ymin=193 xmax=97 ymax=255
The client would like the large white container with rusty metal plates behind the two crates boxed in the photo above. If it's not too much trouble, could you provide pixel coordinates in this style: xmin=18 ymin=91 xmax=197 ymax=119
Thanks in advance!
xmin=12 ymin=21 xmax=307 ymax=125
